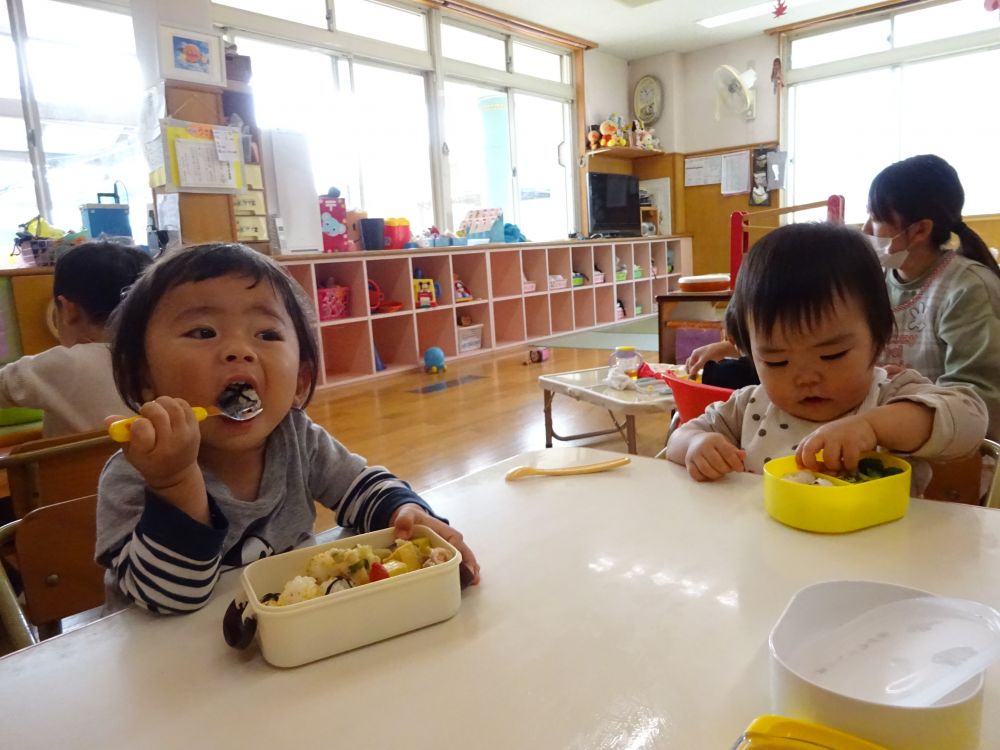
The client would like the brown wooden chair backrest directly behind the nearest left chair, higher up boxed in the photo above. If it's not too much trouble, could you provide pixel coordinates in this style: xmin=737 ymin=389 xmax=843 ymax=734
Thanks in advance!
xmin=0 ymin=430 xmax=120 ymax=518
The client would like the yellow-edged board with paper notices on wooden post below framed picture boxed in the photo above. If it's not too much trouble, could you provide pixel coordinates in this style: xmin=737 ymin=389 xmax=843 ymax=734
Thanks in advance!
xmin=146 ymin=119 xmax=245 ymax=193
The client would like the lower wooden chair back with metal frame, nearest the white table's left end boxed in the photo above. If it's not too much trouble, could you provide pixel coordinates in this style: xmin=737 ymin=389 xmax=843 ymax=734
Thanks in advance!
xmin=0 ymin=495 xmax=104 ymax=648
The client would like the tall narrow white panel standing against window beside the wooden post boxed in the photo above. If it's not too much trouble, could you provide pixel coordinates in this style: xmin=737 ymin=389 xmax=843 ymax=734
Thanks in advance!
xmin=261 ymin=128 xmax=323 ymax=253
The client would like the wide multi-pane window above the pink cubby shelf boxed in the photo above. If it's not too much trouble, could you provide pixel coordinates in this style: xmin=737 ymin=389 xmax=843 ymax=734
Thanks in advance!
xmin=222 ymin=0 xmax=577 ymax=240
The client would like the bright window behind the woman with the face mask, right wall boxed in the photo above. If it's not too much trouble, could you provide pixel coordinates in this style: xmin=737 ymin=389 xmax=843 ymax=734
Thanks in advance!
xmin=787 ymin=0 xmax=1000 ymax=223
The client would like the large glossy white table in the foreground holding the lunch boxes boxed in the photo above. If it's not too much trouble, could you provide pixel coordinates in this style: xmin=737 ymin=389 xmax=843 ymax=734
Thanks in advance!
xmin=0 ymin=448 xmax=1000 ymax=750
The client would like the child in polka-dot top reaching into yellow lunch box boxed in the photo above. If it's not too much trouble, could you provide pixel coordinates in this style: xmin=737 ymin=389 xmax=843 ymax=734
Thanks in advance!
xmin=667 ymin=224 xmax=987 ymax=481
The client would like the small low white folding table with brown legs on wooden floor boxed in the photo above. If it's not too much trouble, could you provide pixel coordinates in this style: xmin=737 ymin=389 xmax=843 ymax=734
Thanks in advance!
xmin=538 ymin=367 xmax=674 ymax=454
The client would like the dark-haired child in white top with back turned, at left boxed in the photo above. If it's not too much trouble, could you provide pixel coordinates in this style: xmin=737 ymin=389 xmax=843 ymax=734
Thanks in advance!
xmin=0 ymin=242 xmax=152 ymax=437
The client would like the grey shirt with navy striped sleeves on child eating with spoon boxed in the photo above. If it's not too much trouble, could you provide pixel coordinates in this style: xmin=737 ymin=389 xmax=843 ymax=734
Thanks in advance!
xmin=96 ymin=409 xmax=430 ymax=613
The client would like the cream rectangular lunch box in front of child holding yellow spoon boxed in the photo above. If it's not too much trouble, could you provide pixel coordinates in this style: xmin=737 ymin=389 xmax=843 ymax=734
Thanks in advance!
xmin=226 ymin=526 xmax=462 ymax=667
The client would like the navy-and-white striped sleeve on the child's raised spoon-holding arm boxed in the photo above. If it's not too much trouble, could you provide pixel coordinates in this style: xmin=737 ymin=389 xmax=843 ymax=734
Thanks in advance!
xmin=111 ymin=490 xmax=229 ymax=614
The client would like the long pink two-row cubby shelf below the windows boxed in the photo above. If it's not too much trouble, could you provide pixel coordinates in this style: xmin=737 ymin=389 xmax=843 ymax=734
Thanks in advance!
xmin=277 ymin=236 xmax=693 ymax=388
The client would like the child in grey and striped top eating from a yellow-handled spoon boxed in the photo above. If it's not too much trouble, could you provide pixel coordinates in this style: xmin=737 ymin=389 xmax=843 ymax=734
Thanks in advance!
xmin=96 ymin=244 xmax=479 ymax=613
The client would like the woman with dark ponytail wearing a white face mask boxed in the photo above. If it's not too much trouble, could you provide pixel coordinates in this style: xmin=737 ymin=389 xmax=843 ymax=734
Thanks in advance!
xmin=864 ymin=154 xmax=1000 ymax=440
